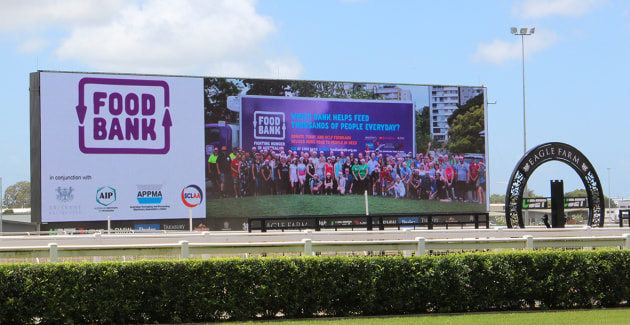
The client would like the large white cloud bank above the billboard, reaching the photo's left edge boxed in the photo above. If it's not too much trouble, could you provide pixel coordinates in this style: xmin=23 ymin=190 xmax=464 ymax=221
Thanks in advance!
xmin=0 ymin=0 xmax=303 ymax=78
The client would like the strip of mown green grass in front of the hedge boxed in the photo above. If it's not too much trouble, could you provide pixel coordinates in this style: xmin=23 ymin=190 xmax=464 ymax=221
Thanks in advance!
xmin=230 ymin=309 xmax=630 ymax=325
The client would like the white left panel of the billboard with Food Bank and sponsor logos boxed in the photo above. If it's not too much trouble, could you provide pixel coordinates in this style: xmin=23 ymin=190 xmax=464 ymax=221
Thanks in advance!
xmin=39 ymin=72 xmax=205 ymax=223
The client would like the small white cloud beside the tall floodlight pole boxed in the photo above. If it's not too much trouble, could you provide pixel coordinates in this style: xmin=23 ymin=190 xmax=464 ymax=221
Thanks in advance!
xmin=471 ymin=29 xmax=558 ymax=65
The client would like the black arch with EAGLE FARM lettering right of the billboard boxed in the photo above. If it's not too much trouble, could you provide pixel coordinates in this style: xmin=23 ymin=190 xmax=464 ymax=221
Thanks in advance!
xmin=505 ymin=142 xmax=604 ymax=228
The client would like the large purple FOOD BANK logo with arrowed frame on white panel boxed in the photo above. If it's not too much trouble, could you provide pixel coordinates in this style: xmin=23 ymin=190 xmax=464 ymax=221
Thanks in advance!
xmin=76 ymin=78 xmax=173 ymax=154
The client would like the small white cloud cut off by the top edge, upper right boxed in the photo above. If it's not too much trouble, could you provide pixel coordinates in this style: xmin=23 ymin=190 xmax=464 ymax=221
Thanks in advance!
xmin=512 ymin=0 xmax=606 ymax=19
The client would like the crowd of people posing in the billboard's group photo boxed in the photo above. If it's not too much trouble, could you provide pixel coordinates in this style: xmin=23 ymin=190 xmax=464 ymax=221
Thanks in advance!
xmin=208 ymin=144 xmax=486 ymax=204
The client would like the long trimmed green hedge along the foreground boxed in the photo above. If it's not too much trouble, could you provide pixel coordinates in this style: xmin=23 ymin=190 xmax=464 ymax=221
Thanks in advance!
xmin=0 ymin=250 xmax=630 ymax=324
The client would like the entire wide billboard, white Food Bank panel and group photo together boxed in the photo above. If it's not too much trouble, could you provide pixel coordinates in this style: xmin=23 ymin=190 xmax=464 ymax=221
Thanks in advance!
xmin=31 ymin=72 xmax=488 ymax=230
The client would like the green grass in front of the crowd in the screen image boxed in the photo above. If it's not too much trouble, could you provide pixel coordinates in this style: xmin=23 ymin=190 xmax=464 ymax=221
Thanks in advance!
xmin=206 ymin=194 xmax=486 ymax=217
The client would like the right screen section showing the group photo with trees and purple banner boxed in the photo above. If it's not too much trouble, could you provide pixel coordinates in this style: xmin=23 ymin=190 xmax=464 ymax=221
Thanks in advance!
xmin=204 ymin=78 xmax=487 ymax=230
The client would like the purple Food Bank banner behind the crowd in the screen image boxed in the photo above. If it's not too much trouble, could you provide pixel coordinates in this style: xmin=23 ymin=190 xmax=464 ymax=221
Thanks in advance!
xmin=241 ymin=96 xmax=415 ymax=154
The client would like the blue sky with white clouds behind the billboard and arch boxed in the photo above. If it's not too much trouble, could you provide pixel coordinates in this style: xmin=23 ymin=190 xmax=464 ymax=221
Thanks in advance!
xmin=0 ymin=0 xmax=630 ymax=198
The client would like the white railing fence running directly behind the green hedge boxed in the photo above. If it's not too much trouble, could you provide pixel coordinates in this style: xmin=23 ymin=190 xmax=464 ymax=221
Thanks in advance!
xmin=0 ymin=234 xmax=630 ymax=262
